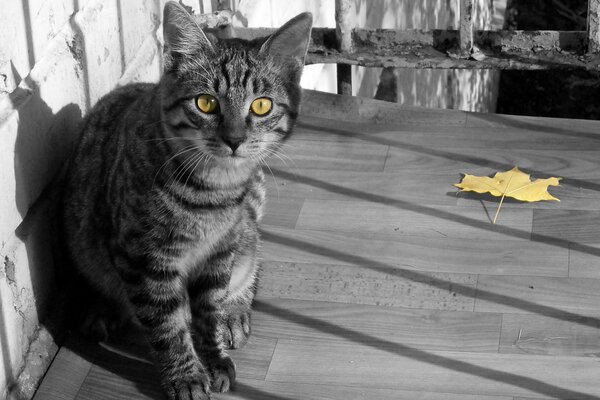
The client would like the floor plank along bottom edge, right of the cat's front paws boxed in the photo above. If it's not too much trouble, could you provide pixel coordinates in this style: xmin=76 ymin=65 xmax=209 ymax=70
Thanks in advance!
xmin=213 ymin=379 xmax=513 ymax=400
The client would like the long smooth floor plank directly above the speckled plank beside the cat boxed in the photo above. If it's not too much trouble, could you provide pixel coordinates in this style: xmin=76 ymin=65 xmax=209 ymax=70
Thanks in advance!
xmin=262 ymin=227 xmax=569 ymax=277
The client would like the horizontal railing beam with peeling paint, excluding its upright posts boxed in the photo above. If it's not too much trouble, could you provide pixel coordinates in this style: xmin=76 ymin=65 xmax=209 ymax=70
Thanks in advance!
xmin=306 ymin=28 xmax=600 ymax=70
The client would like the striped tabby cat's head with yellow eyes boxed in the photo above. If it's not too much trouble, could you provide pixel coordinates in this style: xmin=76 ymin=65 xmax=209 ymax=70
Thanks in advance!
xmin=161 ymin=1 xmax=312 ymax=167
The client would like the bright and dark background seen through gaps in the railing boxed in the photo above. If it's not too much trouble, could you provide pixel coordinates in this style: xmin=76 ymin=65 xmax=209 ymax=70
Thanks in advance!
xmin=232 ymin=0 xmax=600 ymax=119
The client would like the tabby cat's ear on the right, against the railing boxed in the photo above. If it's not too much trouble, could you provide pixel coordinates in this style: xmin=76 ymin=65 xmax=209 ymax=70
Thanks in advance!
xmin=260 ymin=12 xmax=313 ymax=65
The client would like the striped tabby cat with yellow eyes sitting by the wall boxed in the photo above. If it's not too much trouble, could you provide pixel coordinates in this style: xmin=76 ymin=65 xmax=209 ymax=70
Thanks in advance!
xmin=61 ymin=1 xmax=312 ymax=400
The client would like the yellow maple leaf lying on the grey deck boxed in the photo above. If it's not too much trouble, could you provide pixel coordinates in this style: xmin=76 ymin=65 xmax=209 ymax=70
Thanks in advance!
xmin=454 ymin=167 xmax=561 ymax=224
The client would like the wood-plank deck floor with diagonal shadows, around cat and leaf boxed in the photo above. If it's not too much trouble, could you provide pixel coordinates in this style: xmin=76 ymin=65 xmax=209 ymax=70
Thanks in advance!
xmin=35 ymin=92 xmax=600 ymax=400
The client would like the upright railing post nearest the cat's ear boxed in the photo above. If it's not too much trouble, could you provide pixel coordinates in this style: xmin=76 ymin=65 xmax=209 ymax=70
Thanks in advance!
xmin=335 ymin=0 xmax=355 ymax=96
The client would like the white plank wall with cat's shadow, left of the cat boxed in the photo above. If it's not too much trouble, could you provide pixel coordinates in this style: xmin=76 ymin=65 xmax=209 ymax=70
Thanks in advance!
xmin=0 ymin=0 xmax=164 ymax=398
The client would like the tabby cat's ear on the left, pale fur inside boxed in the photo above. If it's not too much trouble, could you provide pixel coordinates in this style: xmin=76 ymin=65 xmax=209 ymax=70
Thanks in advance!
xmin=163 ymin=1 xmax=214 ymax=65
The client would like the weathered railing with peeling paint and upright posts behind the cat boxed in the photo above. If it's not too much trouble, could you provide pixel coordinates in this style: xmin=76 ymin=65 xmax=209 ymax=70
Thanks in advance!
xmin=203 ymin=0 xmax=600 ymax=94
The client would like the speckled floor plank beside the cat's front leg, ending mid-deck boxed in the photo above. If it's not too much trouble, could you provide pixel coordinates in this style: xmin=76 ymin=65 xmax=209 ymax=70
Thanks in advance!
xmin=257 ymin=262 xmax=477 ymax=311
